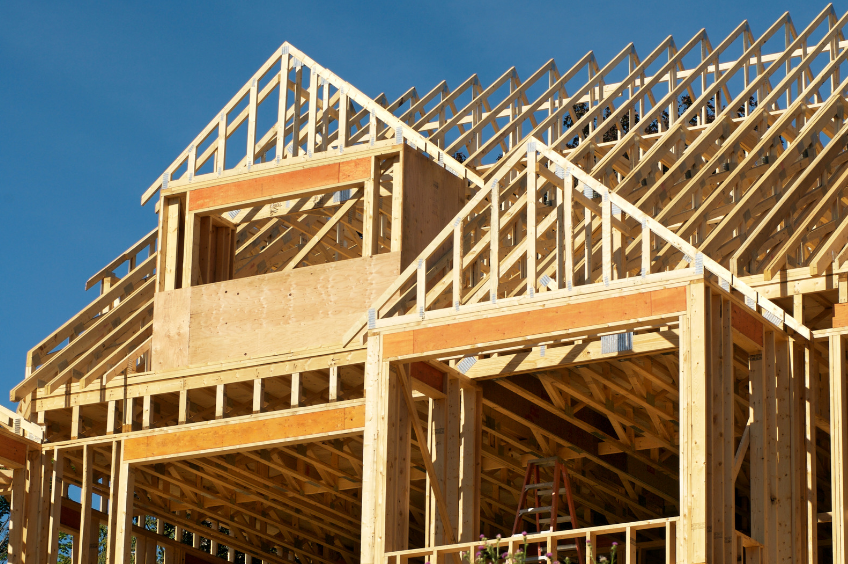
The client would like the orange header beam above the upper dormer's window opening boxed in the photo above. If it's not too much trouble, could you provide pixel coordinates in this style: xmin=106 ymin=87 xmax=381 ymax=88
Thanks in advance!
xmin=189 ymin=157 xmax=371 ymax=211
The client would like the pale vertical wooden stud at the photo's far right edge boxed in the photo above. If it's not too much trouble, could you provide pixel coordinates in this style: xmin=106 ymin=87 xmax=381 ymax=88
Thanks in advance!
xmin=830 ymin=332 xmax=848 ymax=562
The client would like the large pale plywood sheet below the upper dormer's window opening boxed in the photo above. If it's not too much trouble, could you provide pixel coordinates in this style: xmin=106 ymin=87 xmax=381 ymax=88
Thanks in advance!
xmin=187 ymin=253 xmax=400 ymax=365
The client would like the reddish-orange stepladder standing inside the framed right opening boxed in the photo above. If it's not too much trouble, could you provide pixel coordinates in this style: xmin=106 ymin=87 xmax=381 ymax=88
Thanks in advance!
xmin=512 ymin=456 xmax=583 ymax=564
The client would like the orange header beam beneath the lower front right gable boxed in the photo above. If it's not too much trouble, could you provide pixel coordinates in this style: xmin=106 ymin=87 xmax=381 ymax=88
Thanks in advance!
xmin=383 ymin=286 xmax=686 ymax=358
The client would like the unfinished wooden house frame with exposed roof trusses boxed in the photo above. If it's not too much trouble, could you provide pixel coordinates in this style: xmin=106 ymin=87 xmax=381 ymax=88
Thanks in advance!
xmin=8 ymin=6 xmax=848 ymax=564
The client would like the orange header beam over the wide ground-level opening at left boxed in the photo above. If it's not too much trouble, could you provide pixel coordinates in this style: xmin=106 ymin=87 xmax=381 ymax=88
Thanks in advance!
xmin=124 ymin=404 xmax=365 ymax=462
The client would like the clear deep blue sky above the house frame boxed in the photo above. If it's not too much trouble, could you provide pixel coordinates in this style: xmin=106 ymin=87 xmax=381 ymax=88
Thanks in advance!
xmin=0 ymin=0 xmax=846 ymax=405
